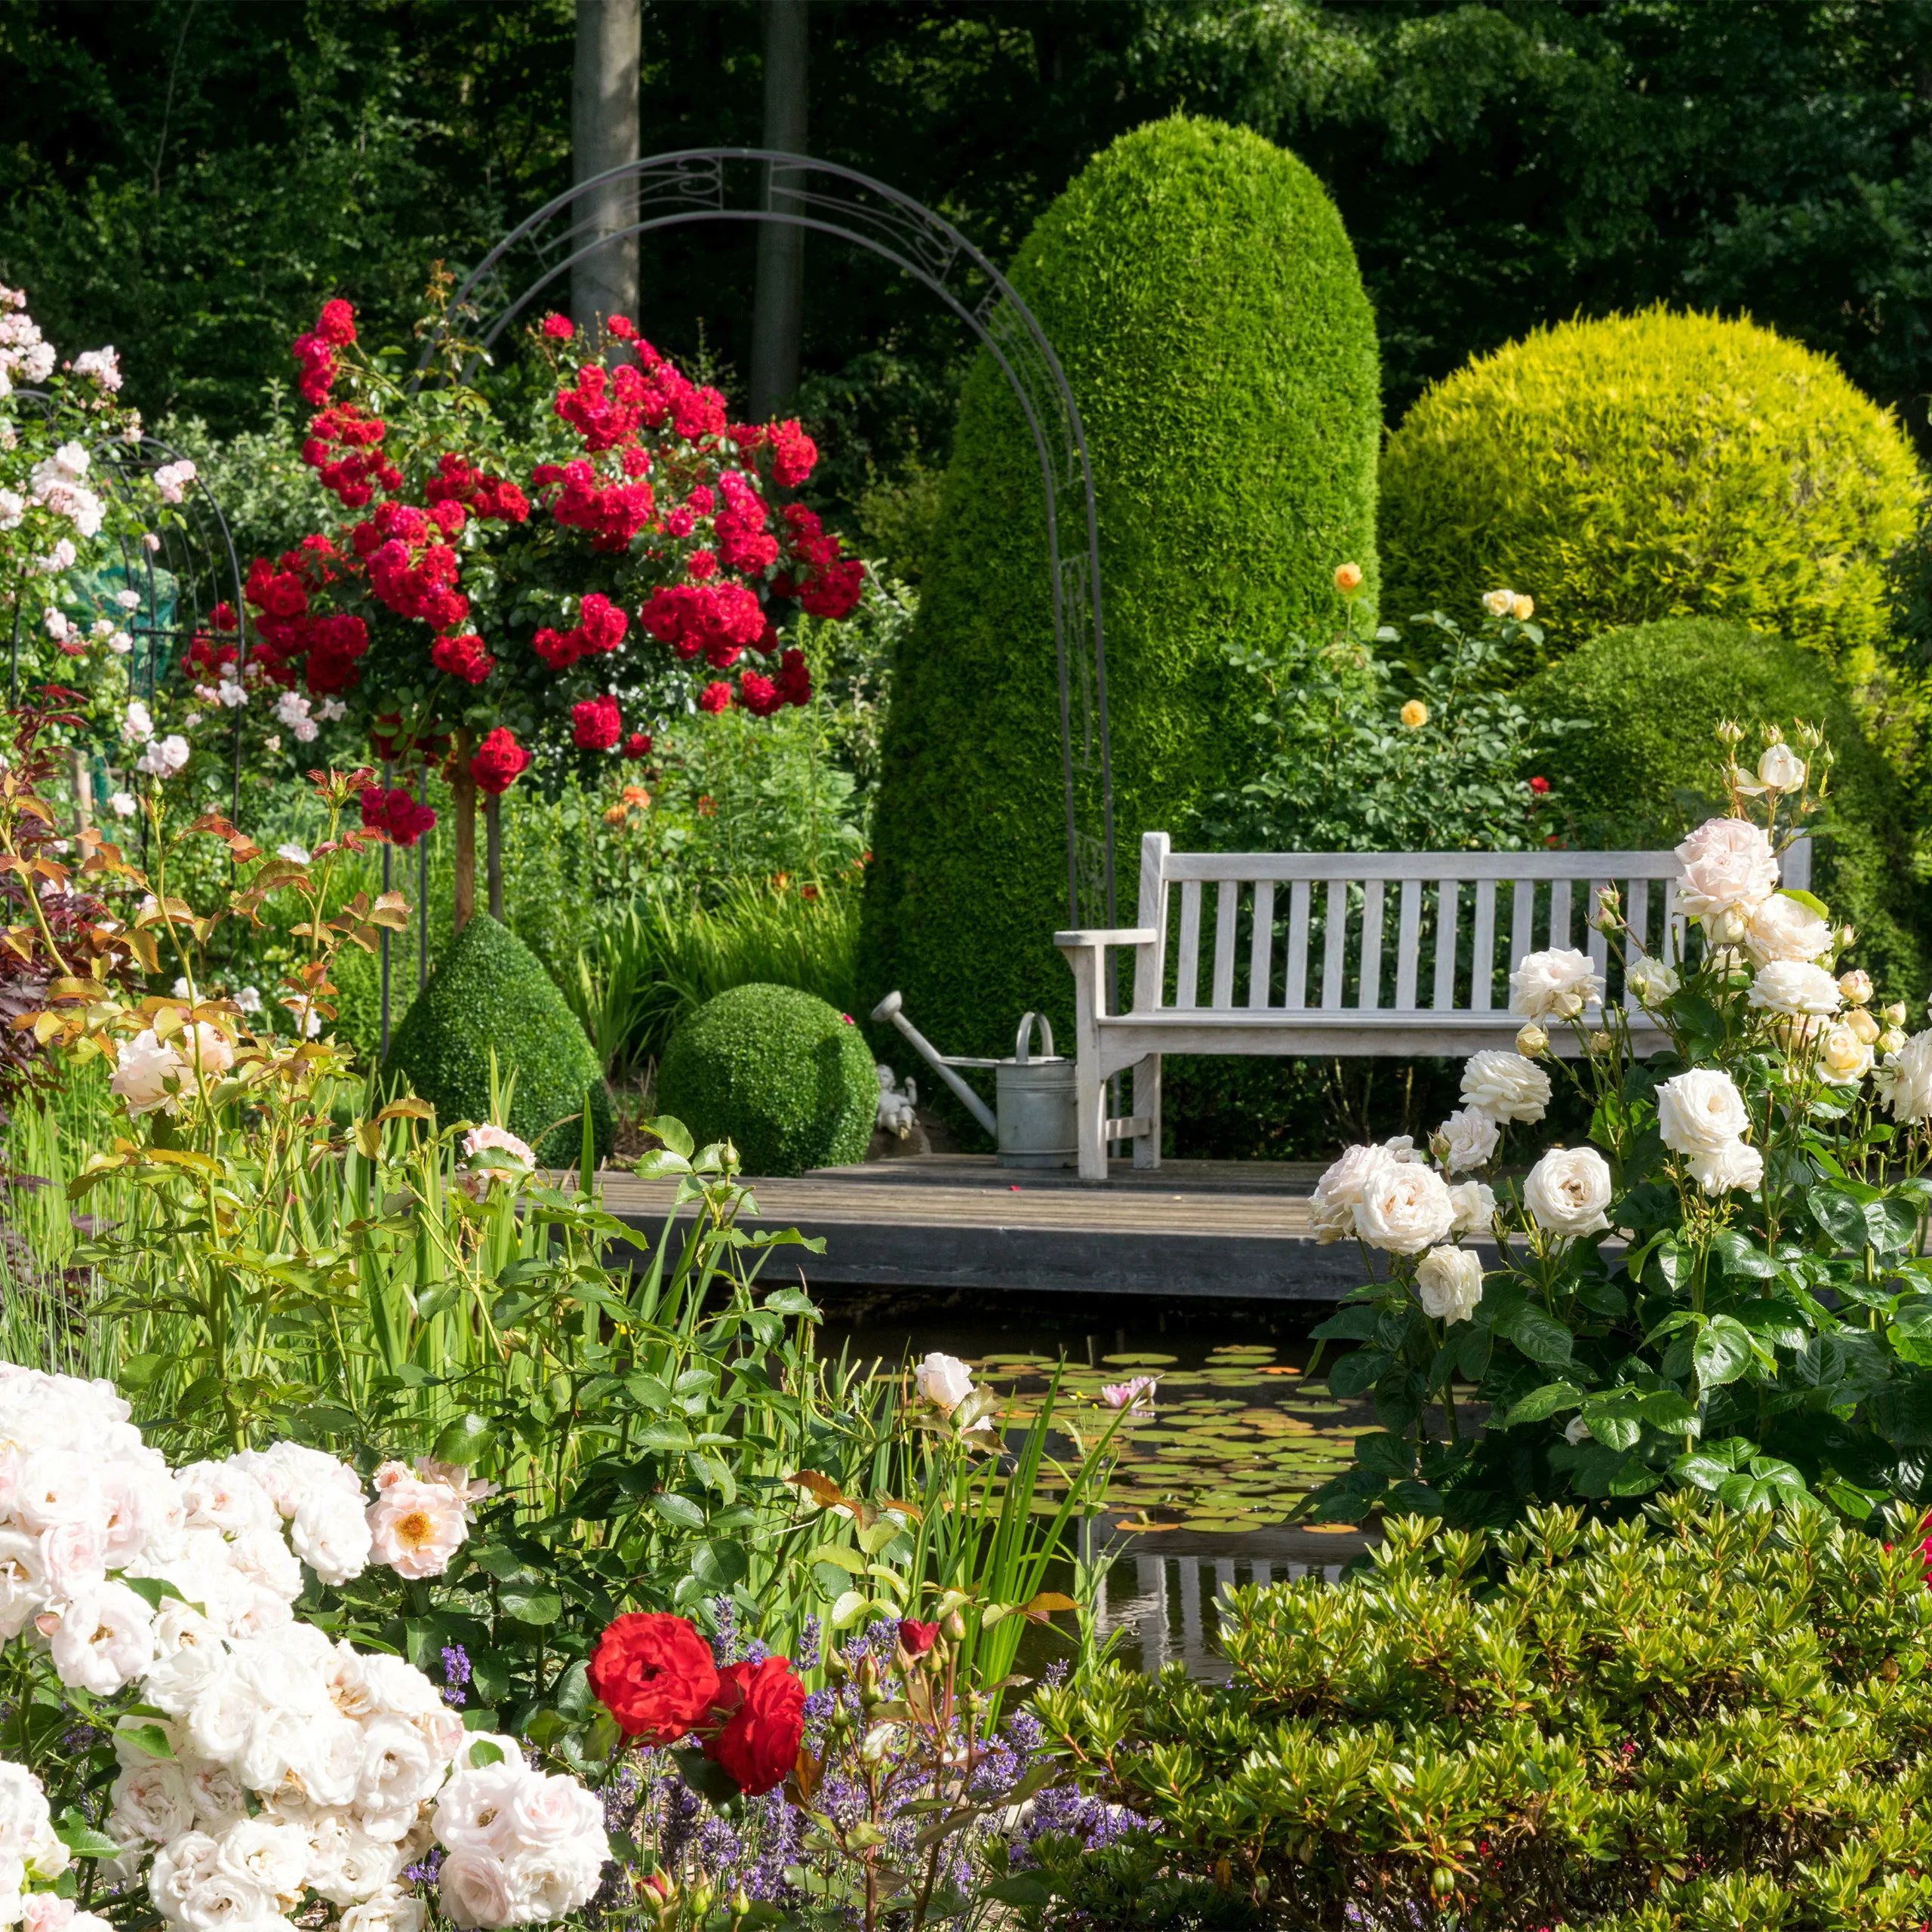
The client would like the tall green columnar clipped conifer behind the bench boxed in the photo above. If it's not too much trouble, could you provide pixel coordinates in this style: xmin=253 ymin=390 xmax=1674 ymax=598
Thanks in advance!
xmin=860 ymin=120 xmax=1380 ymax=1053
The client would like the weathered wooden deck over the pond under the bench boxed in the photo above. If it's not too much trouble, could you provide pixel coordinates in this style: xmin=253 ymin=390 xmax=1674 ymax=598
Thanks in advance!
xmin=603 ymin=1153 xmax=1362 ymax=1302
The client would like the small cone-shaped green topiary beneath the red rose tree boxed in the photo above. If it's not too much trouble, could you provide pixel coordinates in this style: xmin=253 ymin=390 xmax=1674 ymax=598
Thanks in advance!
xmin=383 ymin=912 xmax=614 ymax=1167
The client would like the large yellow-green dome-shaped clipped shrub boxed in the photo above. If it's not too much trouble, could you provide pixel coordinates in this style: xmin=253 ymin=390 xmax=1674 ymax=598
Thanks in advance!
xmin=1381 ymin=307 xmax=1924 ymax=684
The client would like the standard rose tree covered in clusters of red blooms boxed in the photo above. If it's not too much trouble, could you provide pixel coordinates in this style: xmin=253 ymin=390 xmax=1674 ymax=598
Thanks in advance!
xmin=223 ymin=280 xmax=863 ymax=924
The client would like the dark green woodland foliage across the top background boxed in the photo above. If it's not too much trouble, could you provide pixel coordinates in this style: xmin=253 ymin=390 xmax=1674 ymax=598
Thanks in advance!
xmin=0 ymin=0 xmax=1932 ymax=537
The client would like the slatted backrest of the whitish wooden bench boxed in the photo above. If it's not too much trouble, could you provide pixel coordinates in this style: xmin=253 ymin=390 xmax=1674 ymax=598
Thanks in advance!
xmin=1134 ymin=832 xmax=1810 ymax=1017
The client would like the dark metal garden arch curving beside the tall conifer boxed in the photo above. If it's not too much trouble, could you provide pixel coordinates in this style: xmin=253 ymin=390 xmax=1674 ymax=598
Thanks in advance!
xmin=425 ymin=147 xmax=1115 ymax=925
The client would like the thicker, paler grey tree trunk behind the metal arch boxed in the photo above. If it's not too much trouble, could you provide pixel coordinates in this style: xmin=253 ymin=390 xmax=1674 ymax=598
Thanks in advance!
xmin=570 ymin=0 xmax=641 ymax=328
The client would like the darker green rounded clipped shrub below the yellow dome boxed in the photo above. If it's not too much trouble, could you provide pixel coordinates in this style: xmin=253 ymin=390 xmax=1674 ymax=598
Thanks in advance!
xmin=1518 ymin=618 xmax=1928 ymax=1011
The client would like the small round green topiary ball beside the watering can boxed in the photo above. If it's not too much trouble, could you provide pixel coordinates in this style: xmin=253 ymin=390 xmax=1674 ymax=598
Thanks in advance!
xmin=657 ymin=986 xmax=879 ymax=1174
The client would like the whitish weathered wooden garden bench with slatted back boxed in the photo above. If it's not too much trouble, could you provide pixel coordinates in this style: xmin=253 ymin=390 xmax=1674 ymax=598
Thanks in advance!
xmin=1053 ymin=832 xmax=1810 ymax=1180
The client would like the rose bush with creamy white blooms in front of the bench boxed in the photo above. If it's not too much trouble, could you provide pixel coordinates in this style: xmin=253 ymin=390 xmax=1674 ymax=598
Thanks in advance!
xmin=1312 ymin=724 xmax=1932 ymax=1521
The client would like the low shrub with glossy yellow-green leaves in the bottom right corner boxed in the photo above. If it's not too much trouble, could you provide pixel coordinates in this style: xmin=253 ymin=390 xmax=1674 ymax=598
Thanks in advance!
xmin=1028 ymin=1494 xmax=1932 ymax=1932
